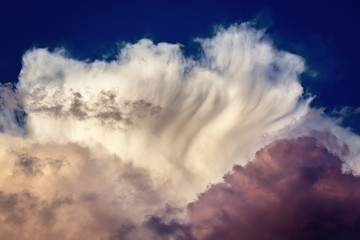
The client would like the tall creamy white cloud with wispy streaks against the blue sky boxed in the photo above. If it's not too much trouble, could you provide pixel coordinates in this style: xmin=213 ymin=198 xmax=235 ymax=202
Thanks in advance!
xmin=18 ymin=24 xmax=309 ymax=201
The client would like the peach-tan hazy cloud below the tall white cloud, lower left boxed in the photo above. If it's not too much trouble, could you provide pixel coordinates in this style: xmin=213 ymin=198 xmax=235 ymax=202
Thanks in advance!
xmin=0 ymin=134 xmax=188 ymax=240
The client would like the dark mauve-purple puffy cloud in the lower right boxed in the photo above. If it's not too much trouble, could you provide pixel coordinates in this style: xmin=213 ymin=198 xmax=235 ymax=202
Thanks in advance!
xmin=189 ymin=137 xmax=360 ymax=240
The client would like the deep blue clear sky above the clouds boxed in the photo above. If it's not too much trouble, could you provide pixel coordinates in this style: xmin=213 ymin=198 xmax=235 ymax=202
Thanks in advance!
xmin=0 ymin=0 xmax=360 ymax=132
